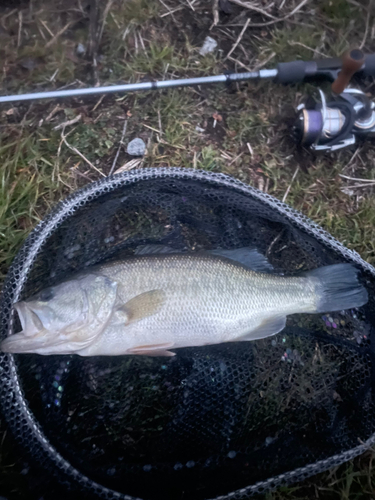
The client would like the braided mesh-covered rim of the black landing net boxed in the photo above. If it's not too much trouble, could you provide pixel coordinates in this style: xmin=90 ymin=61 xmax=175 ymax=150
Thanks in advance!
xmin=0 ymin=167 xmax=375 ymax=500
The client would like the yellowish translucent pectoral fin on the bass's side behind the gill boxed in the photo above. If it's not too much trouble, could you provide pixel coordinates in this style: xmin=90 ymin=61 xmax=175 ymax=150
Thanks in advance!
xmin=117 ymin=290 xmax=165 ymax=325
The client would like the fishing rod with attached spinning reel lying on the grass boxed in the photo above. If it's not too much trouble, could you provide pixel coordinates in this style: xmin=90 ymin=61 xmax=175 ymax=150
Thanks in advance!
xmin=0 ymin=49 xmax=375 ymax=151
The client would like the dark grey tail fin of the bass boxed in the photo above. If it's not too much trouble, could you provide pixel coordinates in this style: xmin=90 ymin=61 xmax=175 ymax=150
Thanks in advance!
xmin=305 ymin=264 xmax=368 ymax=312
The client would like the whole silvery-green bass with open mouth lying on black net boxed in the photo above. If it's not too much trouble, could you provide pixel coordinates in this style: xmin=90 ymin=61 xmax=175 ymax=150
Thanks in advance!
xmin=0 ymin=246 xmax=368 ymax=356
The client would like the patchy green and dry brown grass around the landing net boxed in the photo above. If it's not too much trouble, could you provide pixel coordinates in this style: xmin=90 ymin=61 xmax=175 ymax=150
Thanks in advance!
xmin=0 ymin=0 xmax=375 ymax=500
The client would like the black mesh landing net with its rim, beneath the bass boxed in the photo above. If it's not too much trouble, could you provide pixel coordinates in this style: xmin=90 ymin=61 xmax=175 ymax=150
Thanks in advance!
xmin=0 ymin=168 xmax=375 ymax=500
